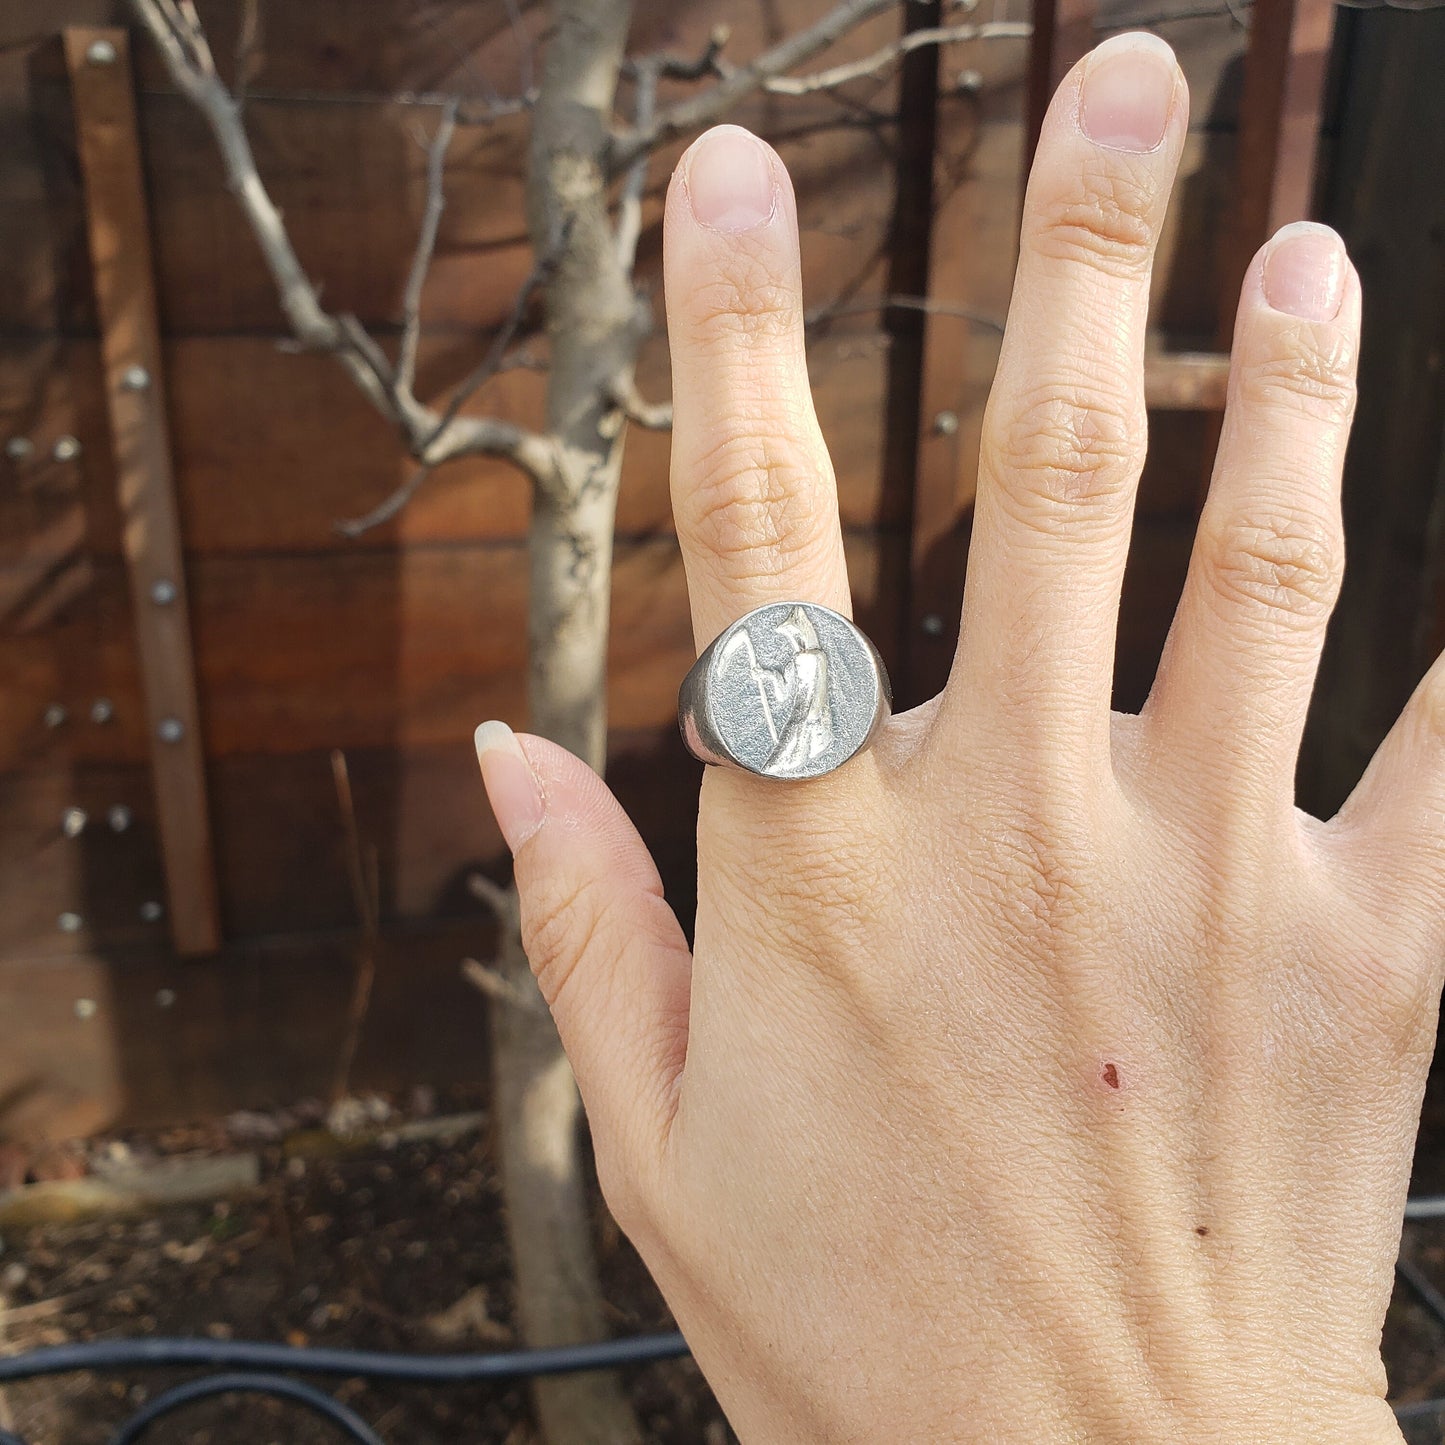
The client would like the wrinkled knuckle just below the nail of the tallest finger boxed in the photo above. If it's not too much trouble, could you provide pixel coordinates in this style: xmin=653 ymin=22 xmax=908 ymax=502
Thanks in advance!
xmin=1033 ymin=165 xmax=1157 ymax=280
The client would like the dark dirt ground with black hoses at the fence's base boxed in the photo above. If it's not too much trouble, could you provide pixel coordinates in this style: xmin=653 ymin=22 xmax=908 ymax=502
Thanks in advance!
xmin=8 ymin=1091 xmax=1445 ymax=1445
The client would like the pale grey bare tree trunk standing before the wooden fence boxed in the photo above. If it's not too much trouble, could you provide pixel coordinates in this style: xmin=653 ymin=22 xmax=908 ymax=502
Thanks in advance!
xmin=491 ymin=0 xmax=642 ymax=1445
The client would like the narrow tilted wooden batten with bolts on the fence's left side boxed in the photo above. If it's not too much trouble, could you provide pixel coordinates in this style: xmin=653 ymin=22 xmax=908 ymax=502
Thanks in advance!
xmin=65 ymin=27 xmax=221 ymax=955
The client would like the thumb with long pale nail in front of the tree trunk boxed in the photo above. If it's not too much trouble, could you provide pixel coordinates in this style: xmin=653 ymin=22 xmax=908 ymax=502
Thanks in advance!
xmin=477 ymin=723 xmax=692 ymax=1179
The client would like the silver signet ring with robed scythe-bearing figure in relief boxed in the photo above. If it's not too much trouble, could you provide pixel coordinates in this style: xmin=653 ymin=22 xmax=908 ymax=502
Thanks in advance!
xmin=678 ymin=603 xmax=893 ymax=777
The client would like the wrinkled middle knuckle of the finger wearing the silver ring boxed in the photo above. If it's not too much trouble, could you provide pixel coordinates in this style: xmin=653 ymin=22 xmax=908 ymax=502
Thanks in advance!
xmin=688 ymin=435 xmax=822 ymax=577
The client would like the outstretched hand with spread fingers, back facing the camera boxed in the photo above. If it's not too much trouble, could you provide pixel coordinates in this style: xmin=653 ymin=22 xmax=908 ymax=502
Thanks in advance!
xmin=480 ymin=36 xmax=1445 ymax=1445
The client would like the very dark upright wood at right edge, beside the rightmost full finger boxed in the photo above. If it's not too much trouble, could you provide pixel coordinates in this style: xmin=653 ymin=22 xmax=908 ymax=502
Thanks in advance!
xmin=1299 ymin=10 xmax=1445 ymax=816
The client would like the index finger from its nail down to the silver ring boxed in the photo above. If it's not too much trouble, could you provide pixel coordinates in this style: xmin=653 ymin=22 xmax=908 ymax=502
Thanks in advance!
xmin=663 ymin=126 xmax=851 ymax=652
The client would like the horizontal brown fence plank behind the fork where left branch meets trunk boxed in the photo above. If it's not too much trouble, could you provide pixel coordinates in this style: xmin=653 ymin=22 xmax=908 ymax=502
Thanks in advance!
xmin=0 ymin=330 xmax=906 ymax=560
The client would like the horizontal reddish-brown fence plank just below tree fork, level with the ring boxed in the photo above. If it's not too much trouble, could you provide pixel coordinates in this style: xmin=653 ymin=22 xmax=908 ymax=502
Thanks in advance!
xmin=0 ymin=533 xmax=906 ymax=773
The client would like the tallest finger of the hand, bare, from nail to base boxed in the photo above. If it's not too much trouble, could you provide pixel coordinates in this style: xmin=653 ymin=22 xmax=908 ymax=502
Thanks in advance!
xmin=939 ymin=33 xmax=1188 ymax=759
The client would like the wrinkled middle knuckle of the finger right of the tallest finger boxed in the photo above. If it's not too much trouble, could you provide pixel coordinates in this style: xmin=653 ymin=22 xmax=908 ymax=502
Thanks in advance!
xmin=1205 ymin=513 xmax=1344 ymax=623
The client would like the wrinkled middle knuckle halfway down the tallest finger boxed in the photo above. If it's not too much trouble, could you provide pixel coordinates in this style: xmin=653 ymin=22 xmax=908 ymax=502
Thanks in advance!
xmin=984 ymin=383 xmax=1144 ymax=525
